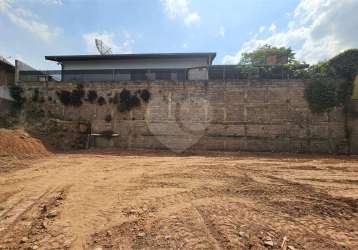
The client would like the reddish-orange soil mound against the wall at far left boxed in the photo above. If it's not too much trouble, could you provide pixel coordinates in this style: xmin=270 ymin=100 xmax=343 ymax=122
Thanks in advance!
xmin=0 ymin=129 xmax=50 ymax=158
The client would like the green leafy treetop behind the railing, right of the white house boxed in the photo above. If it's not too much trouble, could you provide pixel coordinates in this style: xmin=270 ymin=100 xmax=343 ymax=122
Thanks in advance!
xmin=240 ymin=45 xmax=297 ymax=65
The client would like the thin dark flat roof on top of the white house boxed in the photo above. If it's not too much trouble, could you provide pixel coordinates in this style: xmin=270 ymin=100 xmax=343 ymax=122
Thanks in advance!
xmin=45 ymin=52 xmax=216 ymax=62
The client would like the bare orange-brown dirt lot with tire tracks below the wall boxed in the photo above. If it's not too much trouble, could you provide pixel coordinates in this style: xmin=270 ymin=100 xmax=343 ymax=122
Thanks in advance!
xmin=0 ymin=149 xmax=358 ymax=249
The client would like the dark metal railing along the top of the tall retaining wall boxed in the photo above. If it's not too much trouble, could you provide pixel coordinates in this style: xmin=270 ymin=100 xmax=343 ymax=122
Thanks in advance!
xmin=19 ymin=65 xmax=307 ymax=82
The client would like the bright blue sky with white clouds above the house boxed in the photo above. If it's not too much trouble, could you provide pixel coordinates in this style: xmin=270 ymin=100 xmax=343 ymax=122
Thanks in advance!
xmin=0 ymin=0 xmax=358 ymax=69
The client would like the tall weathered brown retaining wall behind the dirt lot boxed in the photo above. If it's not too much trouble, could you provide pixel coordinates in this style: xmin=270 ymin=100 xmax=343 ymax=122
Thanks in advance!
xmin=23 ymin=80 xmax=358 ymax=153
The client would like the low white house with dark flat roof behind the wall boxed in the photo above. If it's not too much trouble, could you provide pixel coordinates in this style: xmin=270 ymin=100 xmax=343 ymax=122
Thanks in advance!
xmin=46 ymin=53 xmax=216 ymax=80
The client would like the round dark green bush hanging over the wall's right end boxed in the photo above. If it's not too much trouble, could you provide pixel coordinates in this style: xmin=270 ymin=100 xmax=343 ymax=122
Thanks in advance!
xmin=305 ymin=78 xmax=339 ymax=113
